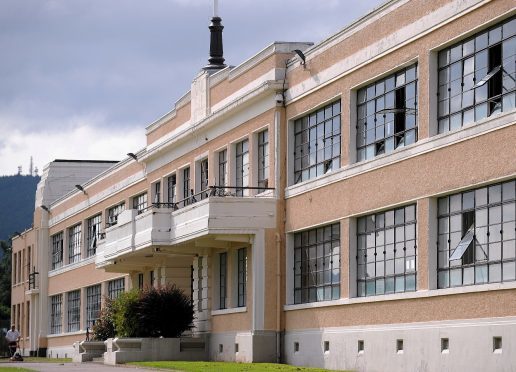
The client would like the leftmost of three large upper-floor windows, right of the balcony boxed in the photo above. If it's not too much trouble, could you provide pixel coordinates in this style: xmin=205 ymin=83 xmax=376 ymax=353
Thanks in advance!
xmin=294 ymin=101 xmax=340 ymax=183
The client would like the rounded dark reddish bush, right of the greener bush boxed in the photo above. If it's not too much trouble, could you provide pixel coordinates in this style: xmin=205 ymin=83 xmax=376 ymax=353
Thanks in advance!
xmin=137 ymin=285 xmax=194 ymax=337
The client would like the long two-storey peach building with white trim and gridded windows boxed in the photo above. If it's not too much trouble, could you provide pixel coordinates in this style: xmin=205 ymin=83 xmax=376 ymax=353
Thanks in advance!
xmin=13 ymin=0 xmax=516 ymax=371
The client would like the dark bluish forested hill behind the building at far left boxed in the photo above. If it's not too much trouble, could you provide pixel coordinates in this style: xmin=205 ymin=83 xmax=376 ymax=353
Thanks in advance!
xmin=0 ymin=175 xmax=40 ymax=246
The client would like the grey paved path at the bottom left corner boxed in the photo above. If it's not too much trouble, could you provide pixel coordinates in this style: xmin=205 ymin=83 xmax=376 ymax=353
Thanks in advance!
xmin=0 ymin=362 xmax=167 ymax=372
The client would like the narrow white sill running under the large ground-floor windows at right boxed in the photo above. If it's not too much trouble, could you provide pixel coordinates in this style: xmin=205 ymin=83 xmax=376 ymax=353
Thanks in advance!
xmin=283 ymin=281 xmax=516 ymax=311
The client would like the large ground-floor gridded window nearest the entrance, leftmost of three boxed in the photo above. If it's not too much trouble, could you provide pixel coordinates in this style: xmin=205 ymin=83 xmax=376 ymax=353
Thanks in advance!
xmin=294 ymin=223 xmax=340 ymax=304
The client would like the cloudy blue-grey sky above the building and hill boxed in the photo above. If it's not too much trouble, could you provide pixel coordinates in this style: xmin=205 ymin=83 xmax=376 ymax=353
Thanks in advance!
xmin=0 ymin=0 xmax=384 ymax=175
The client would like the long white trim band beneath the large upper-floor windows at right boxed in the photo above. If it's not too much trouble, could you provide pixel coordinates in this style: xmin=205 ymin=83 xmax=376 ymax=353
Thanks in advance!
xmin=285 ymin=111 xmax=516 ymax=199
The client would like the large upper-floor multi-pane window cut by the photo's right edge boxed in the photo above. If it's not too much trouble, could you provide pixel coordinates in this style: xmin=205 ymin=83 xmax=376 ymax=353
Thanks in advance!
xmin=437 ymin=18 xmax=516 ymax=133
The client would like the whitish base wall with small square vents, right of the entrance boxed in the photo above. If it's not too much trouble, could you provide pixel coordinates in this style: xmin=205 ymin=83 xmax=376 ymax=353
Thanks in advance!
xmin=284 ymin=316 xmax=516 ymax=372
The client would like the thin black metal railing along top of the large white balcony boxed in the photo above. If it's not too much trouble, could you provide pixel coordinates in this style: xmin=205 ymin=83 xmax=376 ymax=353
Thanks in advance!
xmin=139 ymin=186 xmax=274 ymax=214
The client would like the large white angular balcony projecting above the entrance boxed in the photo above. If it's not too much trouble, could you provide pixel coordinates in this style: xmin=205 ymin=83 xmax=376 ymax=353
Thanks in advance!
xmin=96 ymin=187 xmax=277 ymax=268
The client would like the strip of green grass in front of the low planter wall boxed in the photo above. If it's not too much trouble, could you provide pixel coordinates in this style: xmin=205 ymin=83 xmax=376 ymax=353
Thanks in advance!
xmin=128 ymin=361 xmax=338 ymax=372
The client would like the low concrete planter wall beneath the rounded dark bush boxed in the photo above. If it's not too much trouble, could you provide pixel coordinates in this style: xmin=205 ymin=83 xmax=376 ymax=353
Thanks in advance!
xmin=104 ymin=337 xmax=208 ymax=365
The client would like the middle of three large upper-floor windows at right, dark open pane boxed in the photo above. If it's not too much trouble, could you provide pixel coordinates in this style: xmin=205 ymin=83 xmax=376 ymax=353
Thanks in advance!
xmin=357 ymin=64 xmax=417 ymax=161
